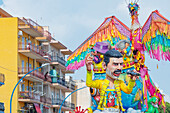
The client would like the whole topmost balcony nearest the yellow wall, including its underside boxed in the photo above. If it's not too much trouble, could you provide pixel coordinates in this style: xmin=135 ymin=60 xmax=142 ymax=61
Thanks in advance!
xmin=18 ymin=18 xmax=44 ymax=37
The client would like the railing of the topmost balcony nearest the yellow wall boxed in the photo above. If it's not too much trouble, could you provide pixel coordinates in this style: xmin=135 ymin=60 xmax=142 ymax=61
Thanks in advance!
xmin=19 ymin=18 xmax=44 ymax=34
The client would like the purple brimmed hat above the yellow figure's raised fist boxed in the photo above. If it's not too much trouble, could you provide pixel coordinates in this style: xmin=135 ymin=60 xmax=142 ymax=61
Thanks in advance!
xmin=93 ymin=42 xmax=109 ymax=54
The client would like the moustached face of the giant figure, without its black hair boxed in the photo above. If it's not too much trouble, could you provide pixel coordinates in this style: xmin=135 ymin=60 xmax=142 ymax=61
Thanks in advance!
xmin=106 ymin=57 xmax=123 ymax=79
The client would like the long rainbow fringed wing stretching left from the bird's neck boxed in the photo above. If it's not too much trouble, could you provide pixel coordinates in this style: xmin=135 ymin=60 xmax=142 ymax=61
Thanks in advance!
xmin=66 ymin=16 xmax=130 ymax=70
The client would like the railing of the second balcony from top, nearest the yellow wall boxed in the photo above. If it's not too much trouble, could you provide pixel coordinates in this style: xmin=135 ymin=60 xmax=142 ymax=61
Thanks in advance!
xmin=18 ymin=43 xmax=45 ymax=57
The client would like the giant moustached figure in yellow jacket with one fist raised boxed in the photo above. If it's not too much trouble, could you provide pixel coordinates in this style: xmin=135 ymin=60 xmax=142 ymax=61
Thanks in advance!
xmin=85 ymin=50 xmax=138 ymax=113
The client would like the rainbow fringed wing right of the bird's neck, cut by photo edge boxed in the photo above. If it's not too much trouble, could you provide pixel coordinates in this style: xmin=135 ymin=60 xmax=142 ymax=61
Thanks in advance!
xmin=142 ymin=10 xmax=170 ymax=61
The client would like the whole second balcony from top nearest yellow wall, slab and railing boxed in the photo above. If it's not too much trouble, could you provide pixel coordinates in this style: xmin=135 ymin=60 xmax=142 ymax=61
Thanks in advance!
xmin=18 ymin=43 xmax=51 ymax=63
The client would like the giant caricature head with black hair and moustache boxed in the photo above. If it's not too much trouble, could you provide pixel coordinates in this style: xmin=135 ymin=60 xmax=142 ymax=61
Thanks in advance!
xmin=104 ymin=50 xmax=123 ymax=79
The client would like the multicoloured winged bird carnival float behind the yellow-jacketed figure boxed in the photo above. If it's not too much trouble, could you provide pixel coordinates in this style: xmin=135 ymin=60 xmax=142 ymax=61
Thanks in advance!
xmin=66 ymin=1 xmax=170 ymax=113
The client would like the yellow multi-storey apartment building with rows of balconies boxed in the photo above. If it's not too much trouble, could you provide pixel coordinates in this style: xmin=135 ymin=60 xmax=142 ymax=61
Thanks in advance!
xmin=0 ymin=8 xmax=75 ymax=113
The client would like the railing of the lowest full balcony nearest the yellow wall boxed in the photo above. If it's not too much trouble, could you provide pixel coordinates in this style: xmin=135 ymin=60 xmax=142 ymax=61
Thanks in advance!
xmin=19 ymin=91 xmax=40 ymax=102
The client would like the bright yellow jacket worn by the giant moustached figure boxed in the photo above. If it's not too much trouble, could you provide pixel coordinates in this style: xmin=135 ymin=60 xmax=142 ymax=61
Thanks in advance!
xmin=86 ymin=71 xmax=135 ymax=111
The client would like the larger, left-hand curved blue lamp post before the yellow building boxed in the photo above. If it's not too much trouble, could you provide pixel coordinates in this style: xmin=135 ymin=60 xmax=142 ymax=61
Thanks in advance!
xmin=10 ymin=63 xmax=49 ymax=113
